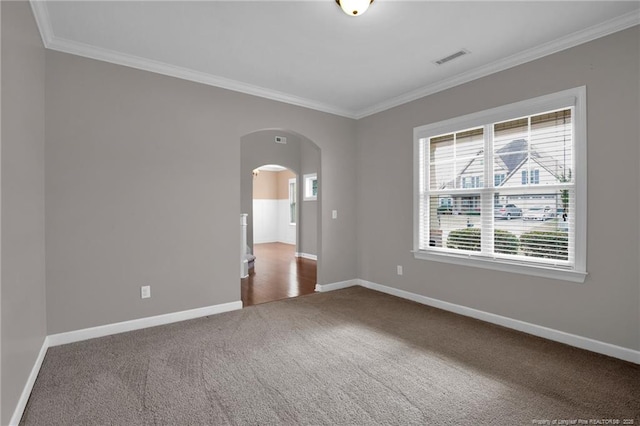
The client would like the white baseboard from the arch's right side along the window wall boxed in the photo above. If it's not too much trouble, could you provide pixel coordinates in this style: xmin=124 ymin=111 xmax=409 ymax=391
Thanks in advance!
xmin=316 ymin=279 xmax=640 ymax=364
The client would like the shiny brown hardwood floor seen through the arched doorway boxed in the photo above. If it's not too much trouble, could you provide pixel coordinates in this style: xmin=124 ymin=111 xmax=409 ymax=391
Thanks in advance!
xmin=241 ymin=243 xmax=317 ymax=306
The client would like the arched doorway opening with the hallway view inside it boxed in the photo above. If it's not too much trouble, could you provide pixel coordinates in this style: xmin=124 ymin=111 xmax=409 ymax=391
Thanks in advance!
xmin=240 ymin=129 xmax=322 ymax=306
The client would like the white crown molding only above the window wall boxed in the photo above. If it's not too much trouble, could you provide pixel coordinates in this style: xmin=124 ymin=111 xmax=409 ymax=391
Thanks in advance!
xmin=355 ymin=10 xmax=640 ymax=119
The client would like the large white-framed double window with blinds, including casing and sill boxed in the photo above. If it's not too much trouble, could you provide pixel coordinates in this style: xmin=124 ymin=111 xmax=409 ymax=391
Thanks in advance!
xmin=414 ymin=87 xmax=586 ymax=282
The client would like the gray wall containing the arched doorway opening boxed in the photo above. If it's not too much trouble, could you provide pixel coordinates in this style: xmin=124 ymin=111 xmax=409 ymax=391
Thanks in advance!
xmin=45 ymin=51 xmax=357 ymax=333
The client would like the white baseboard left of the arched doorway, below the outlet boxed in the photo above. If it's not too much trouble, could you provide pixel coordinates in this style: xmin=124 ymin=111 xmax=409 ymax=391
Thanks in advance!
xmin=48 ymin=301 xmax=242 ymax=346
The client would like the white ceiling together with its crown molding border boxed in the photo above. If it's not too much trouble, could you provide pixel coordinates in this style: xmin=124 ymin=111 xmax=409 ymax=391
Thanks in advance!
xmin=31 ymin=0 xmax=640 ymax=118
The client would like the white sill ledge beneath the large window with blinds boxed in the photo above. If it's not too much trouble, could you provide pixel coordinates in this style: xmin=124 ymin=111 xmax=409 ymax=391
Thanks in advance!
xmin=413 ymin=251 xmax=587 ymax=283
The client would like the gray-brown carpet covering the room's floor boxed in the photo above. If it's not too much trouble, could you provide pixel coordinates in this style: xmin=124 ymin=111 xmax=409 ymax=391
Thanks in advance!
xmin=21 ymin=287 xmax=640 ymax=425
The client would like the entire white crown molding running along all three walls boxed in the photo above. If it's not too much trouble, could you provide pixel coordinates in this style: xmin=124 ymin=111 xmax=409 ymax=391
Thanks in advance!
xmin=29 ymin=0 xmax=640 ymax=120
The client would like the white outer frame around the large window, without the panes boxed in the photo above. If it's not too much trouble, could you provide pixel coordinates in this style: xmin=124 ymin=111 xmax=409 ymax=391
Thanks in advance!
xmin=413 ymin=86 xmax=587 ymax=282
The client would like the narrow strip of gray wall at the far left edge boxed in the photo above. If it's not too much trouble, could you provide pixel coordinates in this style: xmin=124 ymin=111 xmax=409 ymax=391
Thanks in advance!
xmin=0 ymin=2 xmax=46 ymax=424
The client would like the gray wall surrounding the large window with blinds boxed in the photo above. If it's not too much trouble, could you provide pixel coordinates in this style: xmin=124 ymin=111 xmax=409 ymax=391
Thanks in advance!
xmin=357 ymin=27 xmax=640 ymax=350
